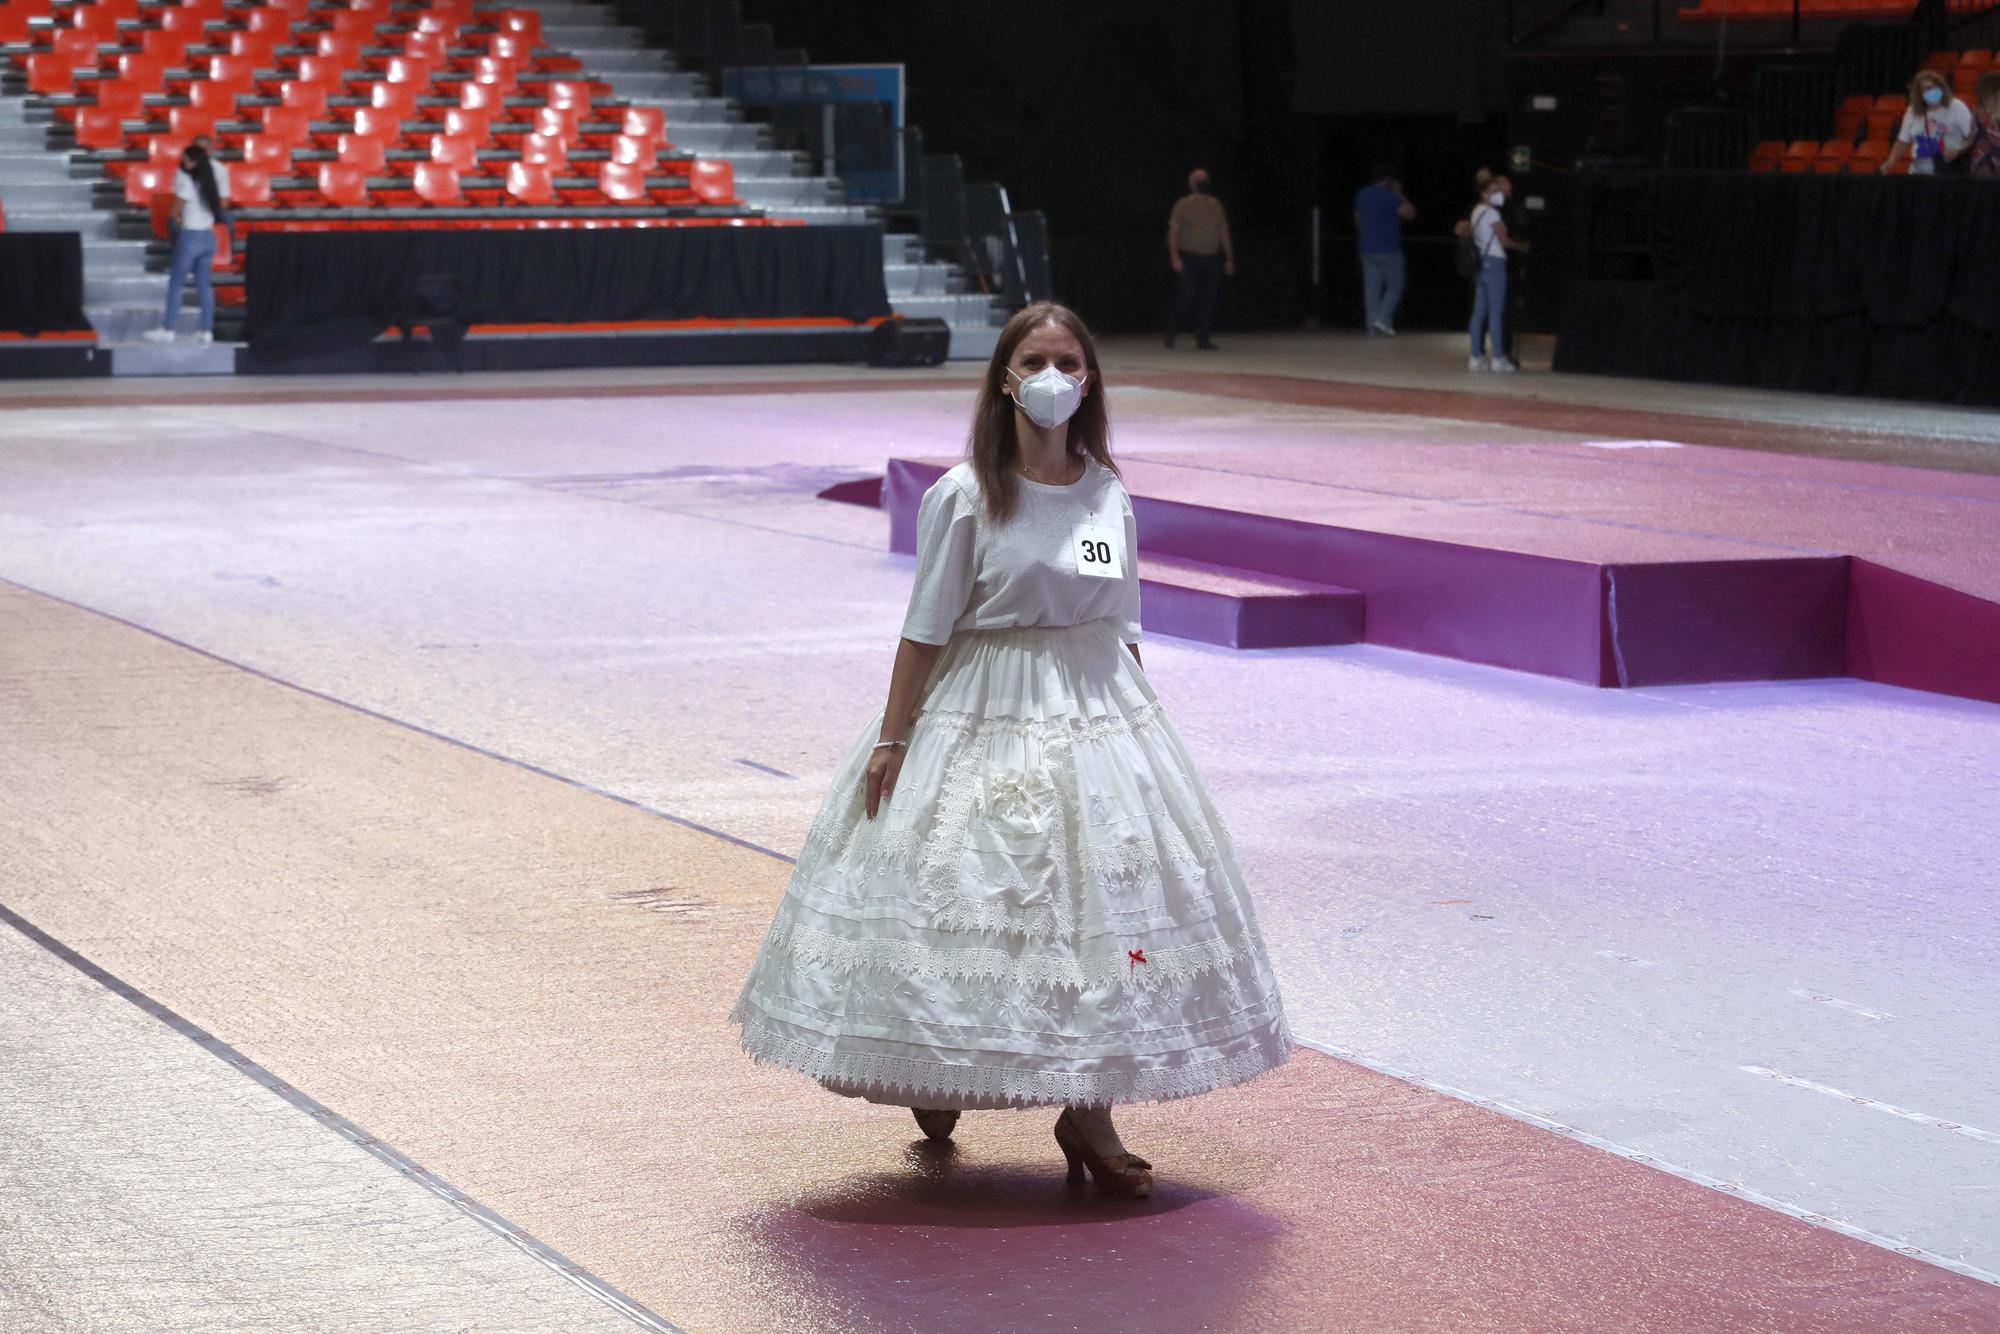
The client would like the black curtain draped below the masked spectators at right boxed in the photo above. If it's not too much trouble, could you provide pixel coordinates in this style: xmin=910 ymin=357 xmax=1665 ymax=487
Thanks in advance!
xmin=1556 ymin=172 xmax=2000 ymax=404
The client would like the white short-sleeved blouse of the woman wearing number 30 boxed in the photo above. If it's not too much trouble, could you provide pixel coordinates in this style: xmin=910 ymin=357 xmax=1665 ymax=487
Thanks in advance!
xmin=902 ymin=458 xmax=1140 ymax=644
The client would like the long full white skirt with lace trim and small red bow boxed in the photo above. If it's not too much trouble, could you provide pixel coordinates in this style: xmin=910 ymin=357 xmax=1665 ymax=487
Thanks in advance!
xmin=730 ymin=620 xmax=1292 ymax=1110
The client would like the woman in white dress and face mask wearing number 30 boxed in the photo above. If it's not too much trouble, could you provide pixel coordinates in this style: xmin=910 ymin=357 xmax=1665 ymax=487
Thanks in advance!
xmin=730 ymin=302 xmax=1292 ymax=1196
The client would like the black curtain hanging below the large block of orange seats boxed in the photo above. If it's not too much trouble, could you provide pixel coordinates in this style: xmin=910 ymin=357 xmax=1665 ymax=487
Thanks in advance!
xmin=244 ymin=226 xmax=890 ymax=358
